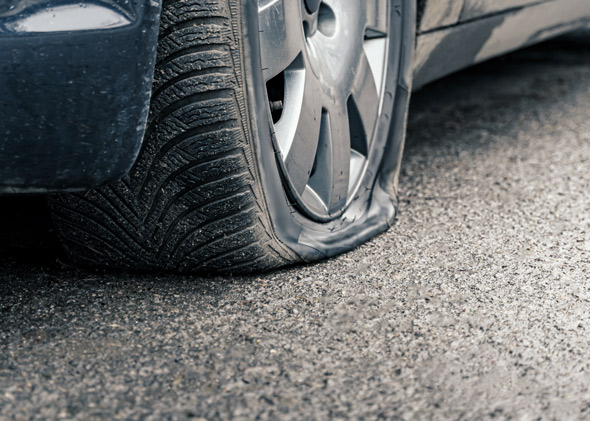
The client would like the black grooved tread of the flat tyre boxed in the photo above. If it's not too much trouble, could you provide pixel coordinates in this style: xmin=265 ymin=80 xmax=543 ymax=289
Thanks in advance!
xmin=51 ymin=0 xmax=297 ymax=272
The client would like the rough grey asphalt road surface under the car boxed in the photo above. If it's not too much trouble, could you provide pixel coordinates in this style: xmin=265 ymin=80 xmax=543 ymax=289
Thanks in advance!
xmin=0 ymin=32 xmax=590 ymax=420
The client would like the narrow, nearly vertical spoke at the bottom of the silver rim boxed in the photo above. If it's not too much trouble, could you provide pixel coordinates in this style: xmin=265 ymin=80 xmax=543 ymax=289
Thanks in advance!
xmin=328 ymin=107 xmax=350 ymax=212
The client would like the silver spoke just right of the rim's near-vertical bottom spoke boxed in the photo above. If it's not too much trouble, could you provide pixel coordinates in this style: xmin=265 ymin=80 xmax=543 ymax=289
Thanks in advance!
xmin=351 ymin=53 xmax=379 ymax=152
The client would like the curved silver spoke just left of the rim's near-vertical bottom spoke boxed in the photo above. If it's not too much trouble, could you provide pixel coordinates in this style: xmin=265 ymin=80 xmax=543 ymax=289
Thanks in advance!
xmin=284 ymin=70 xmax=322 ymax=194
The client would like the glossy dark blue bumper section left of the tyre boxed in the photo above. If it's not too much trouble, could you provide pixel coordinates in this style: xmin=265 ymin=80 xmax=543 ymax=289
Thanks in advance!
xmin=0 ymin=0 xmax=161 ymax=193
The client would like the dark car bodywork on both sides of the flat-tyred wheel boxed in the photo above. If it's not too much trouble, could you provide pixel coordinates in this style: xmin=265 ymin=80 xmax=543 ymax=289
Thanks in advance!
xmin=0 ymin=0 xmax=590 ymax=193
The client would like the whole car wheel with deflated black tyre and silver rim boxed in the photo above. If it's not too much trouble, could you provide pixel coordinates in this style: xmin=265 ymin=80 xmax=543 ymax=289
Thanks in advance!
xmin=52 ymin=0 xmax=415 ymax=272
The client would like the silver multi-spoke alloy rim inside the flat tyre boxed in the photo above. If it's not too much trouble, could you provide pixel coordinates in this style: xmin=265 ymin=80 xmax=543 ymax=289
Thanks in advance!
xmin=258 ymin=0 xmax=389 ymax=220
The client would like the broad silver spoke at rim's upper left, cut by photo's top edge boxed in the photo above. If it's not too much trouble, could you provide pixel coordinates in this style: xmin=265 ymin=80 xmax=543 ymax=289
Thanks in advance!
xmin=258 ymin=0 xmax=305 ymax=81
